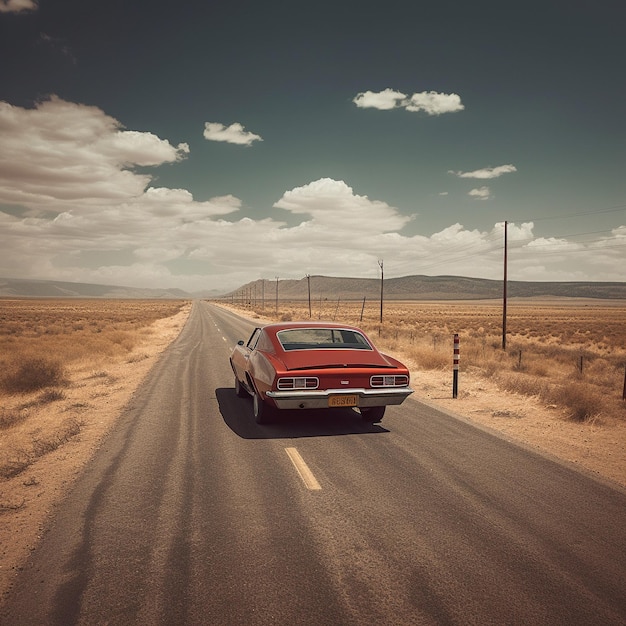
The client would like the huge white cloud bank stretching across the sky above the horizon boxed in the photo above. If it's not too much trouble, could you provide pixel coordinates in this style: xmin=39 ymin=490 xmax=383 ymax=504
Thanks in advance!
xmin=0 ymin=98 xmax=626 ymax=291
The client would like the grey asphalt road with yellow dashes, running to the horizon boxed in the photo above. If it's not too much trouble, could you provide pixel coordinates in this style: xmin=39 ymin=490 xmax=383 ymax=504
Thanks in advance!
xmin=0 ymin=302 xmax=626 ymax=626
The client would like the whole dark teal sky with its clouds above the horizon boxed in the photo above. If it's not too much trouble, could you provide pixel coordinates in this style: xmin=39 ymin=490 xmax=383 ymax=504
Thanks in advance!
xmin=0 ymin=0 xmax=626 ymax=292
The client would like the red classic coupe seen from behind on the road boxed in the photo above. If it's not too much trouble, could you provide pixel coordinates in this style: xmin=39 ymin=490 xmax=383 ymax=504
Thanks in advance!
xmin=230 ymin=322 xmax=413 ymax=424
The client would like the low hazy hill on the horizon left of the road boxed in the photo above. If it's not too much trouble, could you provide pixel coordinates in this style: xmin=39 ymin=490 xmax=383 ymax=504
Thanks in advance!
xmin=0 ymin=278 xmax=192 ymax=300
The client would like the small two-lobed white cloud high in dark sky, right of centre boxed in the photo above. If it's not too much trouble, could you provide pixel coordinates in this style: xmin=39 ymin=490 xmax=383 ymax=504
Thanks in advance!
xmin=352 ymin=88 xmax=465 ymax=115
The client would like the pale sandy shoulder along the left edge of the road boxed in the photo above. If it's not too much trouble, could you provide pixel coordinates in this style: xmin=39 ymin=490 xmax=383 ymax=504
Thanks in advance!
xmin=0 ymin=305 xmax=191 ymax=601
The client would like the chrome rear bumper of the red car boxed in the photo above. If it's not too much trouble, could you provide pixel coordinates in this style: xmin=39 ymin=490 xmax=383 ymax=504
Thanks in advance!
xmin=265 ymin=387 xmax=413 ymax=409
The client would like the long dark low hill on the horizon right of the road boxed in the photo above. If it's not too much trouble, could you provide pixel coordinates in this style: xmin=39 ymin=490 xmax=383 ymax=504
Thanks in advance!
xmin=223 ymin=276 xmax=626 ymax=300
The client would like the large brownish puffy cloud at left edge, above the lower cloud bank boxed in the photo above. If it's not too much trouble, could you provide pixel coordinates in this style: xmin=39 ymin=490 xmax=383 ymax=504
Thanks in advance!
xmin=0 ymin=96 xmax=189 ymax=210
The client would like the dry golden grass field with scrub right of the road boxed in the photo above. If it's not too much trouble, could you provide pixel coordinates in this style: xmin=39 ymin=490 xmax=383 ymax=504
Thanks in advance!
xmin=229 ymin=300 xmax=626 ymax=422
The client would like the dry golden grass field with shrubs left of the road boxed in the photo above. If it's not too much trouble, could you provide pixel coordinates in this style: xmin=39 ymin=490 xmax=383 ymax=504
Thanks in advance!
xmin=0 ymin=299 xmax=185 ymax=479
